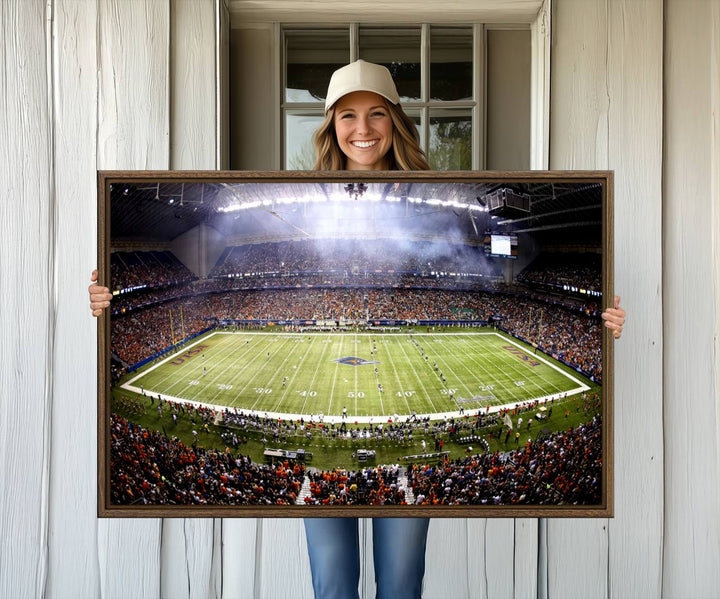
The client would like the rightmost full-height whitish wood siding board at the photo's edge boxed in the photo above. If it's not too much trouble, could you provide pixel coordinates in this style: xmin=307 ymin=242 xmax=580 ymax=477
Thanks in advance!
xmin=663 ymin=0 xmax=720 ymax=597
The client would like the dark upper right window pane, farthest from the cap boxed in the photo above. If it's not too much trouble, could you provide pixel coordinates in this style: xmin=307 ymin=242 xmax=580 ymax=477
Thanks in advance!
xmin=430 ymin=27 xmax=473 ymax=100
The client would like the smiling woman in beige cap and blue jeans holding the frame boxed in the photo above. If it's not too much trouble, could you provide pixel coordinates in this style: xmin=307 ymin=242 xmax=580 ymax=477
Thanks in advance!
xmin=89 ymin=60 xmax=625 ymax=599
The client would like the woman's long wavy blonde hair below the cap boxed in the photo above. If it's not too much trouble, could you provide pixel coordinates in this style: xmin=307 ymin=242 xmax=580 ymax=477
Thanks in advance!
xmin=312 ymin=102 xmax=430 ymax=171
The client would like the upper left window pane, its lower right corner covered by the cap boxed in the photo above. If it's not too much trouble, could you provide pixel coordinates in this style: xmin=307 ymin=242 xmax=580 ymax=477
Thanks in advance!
xmin=285 ymin=29 xmax=350 ymax=102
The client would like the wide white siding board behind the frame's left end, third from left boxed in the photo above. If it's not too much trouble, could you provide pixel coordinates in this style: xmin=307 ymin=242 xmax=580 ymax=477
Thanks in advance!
xmin=97 ymin=0 xmax=170 ymax=599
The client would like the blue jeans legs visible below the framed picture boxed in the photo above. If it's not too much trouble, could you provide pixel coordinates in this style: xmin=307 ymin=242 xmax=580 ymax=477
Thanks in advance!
xmin=305 ymin=518 xmax=430 ymax=599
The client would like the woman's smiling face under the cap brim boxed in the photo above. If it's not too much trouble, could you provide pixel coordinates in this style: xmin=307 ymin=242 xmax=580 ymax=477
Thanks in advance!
xmin=333 ymin=91 xmax=393 ymax=171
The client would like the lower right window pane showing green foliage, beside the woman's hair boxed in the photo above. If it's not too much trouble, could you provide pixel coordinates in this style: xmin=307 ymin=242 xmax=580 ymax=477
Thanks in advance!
xmin=428 ymin=108 xmax=472 ymax=171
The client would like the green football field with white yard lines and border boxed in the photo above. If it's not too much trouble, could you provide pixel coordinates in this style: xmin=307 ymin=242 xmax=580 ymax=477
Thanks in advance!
xmin=122 ymin=329 xmax=589 ymax=420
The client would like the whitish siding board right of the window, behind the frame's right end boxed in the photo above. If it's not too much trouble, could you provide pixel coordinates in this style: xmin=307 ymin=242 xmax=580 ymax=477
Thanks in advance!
xmin=543 ymin=0 xmax=612 ymax=599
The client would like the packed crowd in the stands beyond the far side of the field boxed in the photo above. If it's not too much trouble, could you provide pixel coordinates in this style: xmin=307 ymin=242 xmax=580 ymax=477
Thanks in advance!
xmin=107 ymin=240 xmax=601 ymax=380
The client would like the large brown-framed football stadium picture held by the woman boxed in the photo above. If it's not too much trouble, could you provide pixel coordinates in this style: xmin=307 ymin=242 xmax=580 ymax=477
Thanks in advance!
xmin=98 ymin=171 xmax=613 ymax=517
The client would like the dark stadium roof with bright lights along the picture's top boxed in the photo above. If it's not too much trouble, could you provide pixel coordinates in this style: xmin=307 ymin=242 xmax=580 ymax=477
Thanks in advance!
xmin=110 ymin=178 xmax=602 ymax=242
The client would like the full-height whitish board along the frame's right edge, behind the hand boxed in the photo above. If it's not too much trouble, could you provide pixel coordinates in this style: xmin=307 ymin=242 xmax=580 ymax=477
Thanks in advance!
xmin=604 ymin=0 xmax=666 ymax=597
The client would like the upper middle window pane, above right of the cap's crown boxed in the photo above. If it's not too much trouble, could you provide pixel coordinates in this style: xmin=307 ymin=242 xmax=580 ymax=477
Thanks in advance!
xmin=359 ymin=27 xmax=421 ymax=102
